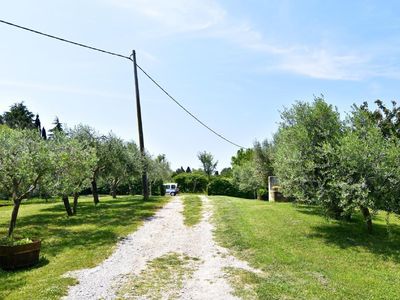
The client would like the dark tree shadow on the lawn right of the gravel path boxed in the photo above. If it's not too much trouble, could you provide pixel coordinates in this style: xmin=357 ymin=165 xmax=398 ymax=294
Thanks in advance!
xmin=296 ymin=205 xmax=400 ymax=263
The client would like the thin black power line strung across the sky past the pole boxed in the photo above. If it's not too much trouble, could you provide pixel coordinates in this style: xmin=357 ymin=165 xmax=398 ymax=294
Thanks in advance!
xmin=0 ymin=19 xmax=246 ymax=148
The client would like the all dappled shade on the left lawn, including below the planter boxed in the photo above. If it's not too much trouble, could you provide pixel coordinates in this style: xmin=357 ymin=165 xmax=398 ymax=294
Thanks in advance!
xmin=0 ymin=197 xmax=169 ymax=298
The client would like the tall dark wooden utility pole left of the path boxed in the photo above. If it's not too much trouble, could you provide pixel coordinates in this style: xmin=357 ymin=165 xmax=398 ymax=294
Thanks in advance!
xmin=132 ymin=50 xmax=149 ymax=200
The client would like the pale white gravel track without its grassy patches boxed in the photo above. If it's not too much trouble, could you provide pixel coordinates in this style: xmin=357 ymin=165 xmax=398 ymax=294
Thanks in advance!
xmin=64 ymin=196 xmax=258 ymax=299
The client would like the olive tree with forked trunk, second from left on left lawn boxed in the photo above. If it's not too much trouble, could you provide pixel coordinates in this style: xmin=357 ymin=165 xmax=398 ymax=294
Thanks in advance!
xmin=46 ymin=132 xmax=97 ymax=216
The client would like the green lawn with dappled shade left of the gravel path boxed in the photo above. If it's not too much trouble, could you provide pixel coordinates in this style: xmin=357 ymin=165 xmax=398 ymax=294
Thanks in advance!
xmin=0 ymin=196 xmax=169 ymax=299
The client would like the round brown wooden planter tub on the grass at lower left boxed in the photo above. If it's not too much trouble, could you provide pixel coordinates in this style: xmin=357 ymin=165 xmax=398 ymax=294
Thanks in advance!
xmin=0 ymin=240 xmax=41 ymax=270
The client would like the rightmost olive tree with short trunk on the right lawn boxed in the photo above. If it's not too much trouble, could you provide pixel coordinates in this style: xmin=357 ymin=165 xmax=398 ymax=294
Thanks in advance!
xmin=327 ymin=107 xmax=400 ymax=232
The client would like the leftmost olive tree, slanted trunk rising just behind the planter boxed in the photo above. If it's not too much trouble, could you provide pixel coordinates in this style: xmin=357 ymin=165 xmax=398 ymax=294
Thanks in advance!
xmin=0 ymin=125 xmax=52 ymax=236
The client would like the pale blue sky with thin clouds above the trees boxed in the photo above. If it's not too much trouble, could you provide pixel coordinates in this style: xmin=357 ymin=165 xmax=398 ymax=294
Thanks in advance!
xmin=0 ymin=0 xmax=400 ymax=169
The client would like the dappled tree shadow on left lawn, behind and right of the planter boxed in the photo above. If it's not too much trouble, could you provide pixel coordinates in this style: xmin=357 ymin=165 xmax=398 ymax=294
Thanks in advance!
xmin=11 ymin=198 xmax=163 ymax=255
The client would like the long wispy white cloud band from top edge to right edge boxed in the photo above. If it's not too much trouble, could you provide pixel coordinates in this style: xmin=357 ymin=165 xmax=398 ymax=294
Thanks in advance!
xmin=108 ymin=0 xmax=400 ymax=80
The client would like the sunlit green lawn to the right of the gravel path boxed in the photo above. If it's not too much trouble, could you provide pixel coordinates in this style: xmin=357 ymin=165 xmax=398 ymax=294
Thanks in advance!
xmin=210 ymin=196 xmax=400 ymax=299
